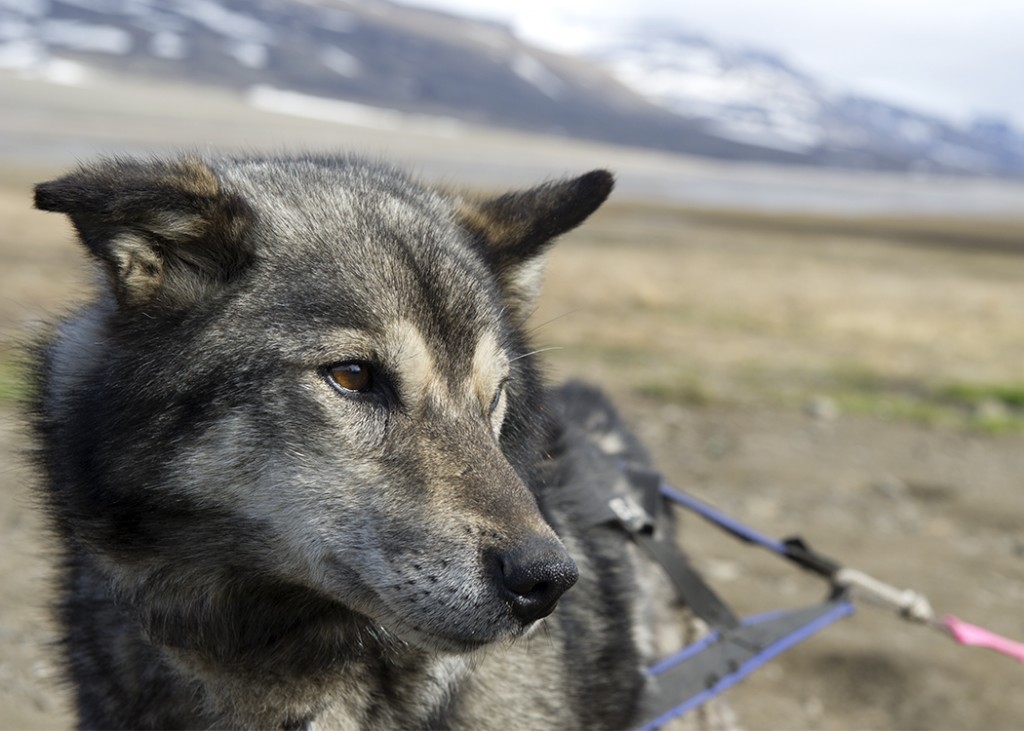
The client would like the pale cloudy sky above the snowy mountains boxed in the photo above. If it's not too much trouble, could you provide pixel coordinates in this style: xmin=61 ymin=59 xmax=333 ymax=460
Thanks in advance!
xmin=399 ymin=0 xmax=1024 ymax=130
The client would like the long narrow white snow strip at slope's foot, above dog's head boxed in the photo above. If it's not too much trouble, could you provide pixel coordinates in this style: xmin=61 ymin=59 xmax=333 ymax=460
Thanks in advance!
xmin=246 ymin=86 xmax=463 ymax=137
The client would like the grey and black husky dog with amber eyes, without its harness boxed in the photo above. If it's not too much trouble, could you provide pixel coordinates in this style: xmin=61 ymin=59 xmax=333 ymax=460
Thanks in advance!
xmin=28 ymin=157 xmax=724 ymax=730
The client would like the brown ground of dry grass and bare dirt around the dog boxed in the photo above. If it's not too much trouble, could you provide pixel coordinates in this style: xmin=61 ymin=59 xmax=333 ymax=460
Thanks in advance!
xmin=0 ymin=166 xmax=1024 ymax=729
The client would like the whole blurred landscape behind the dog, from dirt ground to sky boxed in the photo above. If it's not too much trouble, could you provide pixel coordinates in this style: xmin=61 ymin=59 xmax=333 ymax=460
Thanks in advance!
xmin=0 ymin=0 xmax=1024 ymax=729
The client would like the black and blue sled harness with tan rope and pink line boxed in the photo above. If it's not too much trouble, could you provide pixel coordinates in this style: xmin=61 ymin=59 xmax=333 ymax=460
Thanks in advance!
xmin=573 ymin=465 xmax=1024 ymax=731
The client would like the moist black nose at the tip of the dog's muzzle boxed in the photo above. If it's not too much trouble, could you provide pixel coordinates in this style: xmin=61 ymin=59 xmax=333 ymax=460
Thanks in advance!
xmin=497 ymin=541 xmax=580 ymax=624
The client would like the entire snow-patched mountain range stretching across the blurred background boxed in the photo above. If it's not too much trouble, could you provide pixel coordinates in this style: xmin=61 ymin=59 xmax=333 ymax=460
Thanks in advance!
xmin=0 ymin=0 xmax=1024 ymax=175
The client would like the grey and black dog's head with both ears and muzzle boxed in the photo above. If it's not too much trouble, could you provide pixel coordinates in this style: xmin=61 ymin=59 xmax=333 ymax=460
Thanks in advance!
xmin=36 ymin=153 xmax=611 ymax=650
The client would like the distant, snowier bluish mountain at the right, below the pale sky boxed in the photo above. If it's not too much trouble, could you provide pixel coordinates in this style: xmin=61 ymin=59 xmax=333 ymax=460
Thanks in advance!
xmin=585 ymin=25 xmax=1024 ymax=174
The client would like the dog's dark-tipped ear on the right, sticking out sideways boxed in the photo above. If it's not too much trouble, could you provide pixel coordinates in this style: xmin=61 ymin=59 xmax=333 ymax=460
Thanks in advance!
xmin=458 ymin=170 xmax=614 ymax=325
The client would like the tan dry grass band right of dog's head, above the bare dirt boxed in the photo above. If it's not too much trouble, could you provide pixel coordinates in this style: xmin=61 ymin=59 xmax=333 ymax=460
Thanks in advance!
xmin=536 ymin=196 xmax=1024 ymax=428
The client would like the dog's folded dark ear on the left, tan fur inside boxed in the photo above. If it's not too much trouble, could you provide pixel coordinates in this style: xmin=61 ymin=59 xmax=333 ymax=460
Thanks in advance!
xmin=36 ymin=158 xmax=252 ymax=308
